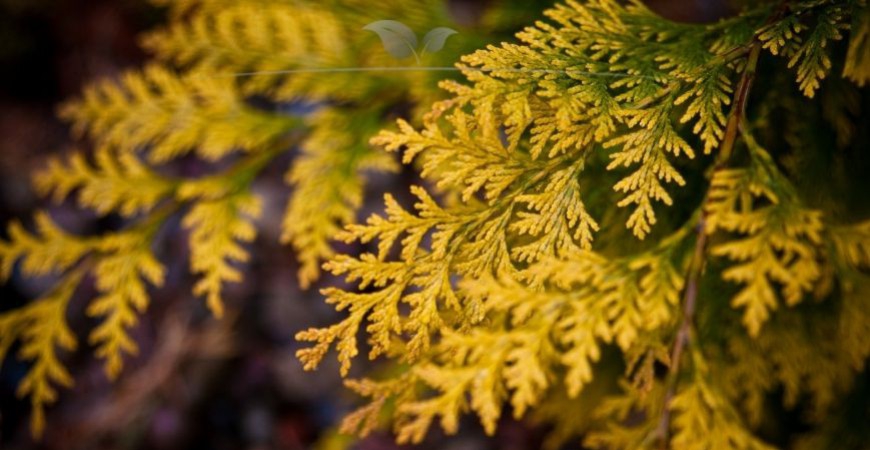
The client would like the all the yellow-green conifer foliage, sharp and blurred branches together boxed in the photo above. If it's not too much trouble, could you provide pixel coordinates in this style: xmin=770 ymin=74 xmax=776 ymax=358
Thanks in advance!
xmin=0 ymin=0 xmax=870 ymax=449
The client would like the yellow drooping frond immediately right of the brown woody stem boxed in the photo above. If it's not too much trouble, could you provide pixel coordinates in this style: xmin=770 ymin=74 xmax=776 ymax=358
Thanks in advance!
xmin=708 ymin=139 xmax=823 ymax=336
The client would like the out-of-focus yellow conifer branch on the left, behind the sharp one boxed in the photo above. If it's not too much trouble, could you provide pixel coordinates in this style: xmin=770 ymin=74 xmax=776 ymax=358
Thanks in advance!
xmin=0 ymin=0 xmax=544 ymax=435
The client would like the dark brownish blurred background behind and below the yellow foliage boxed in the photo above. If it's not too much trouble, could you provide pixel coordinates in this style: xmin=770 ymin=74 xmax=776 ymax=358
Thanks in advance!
xmin=0 ymin=0 xmax=726 ymax=450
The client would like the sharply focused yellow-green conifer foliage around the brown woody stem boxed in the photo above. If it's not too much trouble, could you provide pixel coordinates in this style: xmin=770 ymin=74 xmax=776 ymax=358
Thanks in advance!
xmin=297 ymin=0 xmax=870 ymax=449
